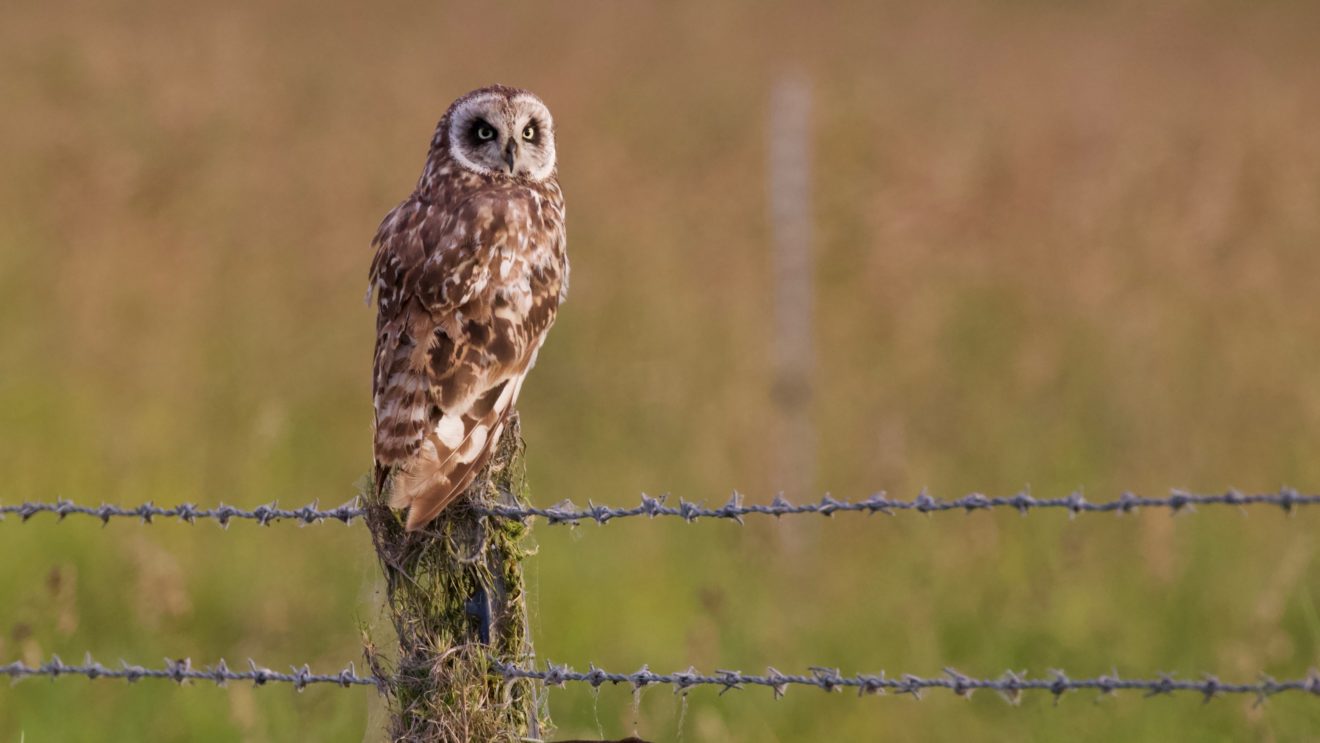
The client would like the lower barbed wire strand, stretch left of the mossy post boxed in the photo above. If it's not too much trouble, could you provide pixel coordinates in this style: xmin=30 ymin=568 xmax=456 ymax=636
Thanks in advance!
xmin=0 ymin=653 xmax=381 ymax=692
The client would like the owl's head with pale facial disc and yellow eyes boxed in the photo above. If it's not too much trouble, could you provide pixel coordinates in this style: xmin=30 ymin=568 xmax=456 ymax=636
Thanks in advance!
xmin=441 ymin=86 xmax=554 ymax=181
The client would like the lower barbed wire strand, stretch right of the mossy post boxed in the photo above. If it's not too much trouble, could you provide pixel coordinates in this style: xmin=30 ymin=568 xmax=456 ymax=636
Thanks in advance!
xmin=492 ymin=659 xmax=1320 ymax=703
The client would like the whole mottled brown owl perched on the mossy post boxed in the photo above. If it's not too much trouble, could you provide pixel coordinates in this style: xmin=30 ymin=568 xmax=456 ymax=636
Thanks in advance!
xmin=367 ymin=86 xmax=569 ymax=531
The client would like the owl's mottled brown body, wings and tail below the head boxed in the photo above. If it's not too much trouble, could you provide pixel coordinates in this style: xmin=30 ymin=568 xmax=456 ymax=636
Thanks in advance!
xmin=371 ymin=183 xmax=568 ymax=529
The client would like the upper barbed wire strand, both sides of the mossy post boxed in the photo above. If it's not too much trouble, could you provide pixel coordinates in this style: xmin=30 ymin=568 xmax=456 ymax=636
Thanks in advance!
xmin=0 ymin=488 xmax=1320 ymax=528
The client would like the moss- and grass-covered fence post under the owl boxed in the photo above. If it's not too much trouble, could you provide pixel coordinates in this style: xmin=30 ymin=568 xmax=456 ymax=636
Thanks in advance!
xmin=364 ymin=413 xmax=549 ymax=743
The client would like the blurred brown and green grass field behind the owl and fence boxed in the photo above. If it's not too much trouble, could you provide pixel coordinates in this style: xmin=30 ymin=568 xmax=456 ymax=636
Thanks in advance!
xmin=0 ymin=0 xmax=1320 ymax=743
